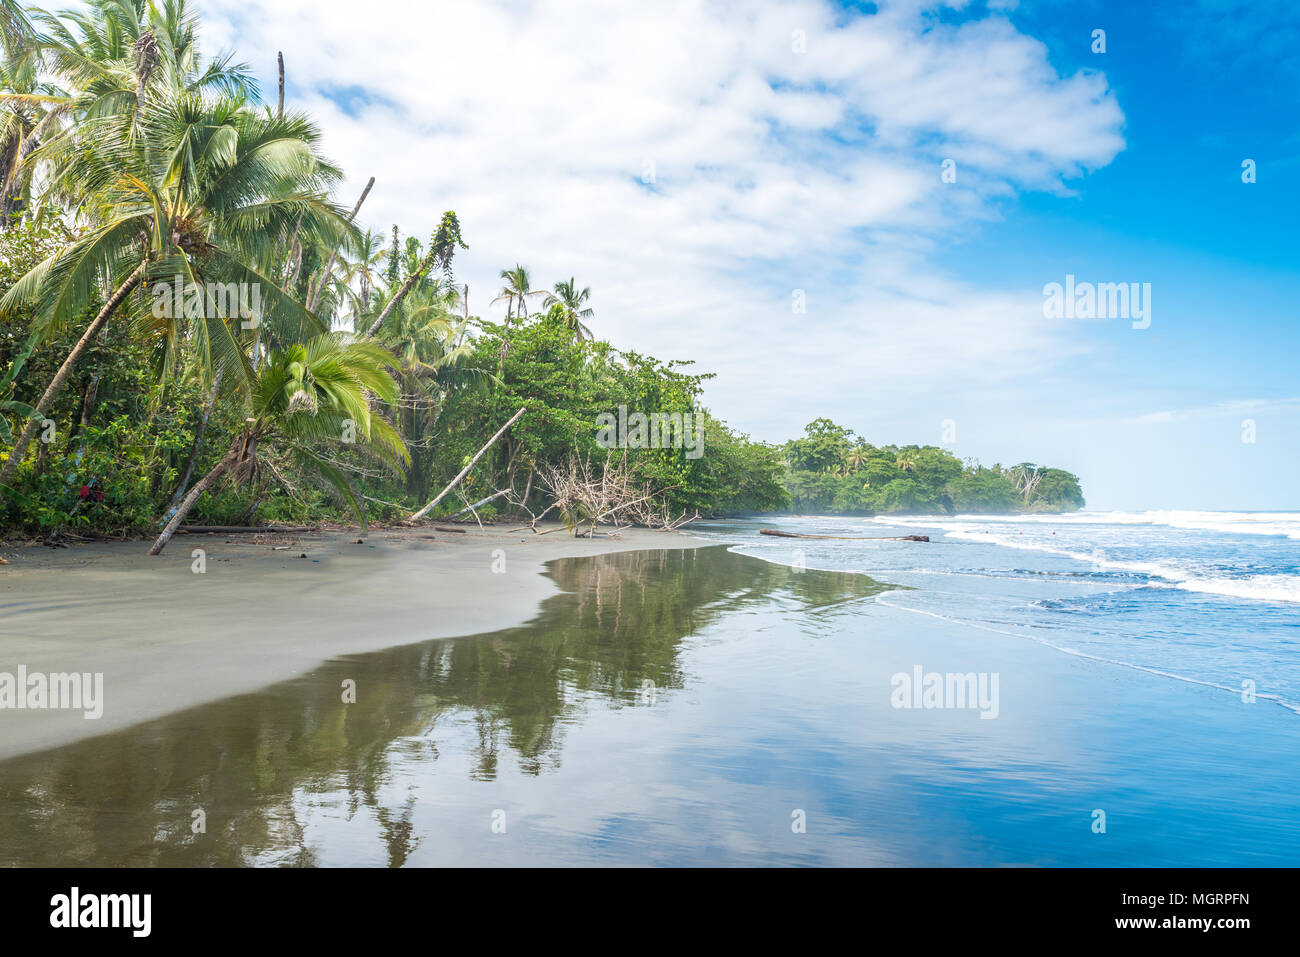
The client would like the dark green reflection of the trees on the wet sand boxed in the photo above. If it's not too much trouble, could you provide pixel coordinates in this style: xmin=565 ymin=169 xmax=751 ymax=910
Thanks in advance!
xmin=0 ymin=547 xmax=881 ymax=866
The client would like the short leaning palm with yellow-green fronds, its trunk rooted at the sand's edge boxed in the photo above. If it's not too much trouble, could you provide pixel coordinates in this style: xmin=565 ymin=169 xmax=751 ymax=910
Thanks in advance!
xmin=150 ymin=333 xmax=410 ymax=555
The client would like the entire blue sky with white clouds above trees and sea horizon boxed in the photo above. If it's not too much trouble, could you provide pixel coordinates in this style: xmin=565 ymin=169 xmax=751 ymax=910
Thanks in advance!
xmin=199 ymin=0 xmax=1300 ymax=510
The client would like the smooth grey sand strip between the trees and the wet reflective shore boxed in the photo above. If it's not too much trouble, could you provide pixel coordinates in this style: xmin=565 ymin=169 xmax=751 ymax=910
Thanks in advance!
xmin=0 ymin=525 xmax=711 ymax=761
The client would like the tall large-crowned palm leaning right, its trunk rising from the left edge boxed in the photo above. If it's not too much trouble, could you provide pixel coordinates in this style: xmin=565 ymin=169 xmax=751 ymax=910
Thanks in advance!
xmin=0 ymin=92 xmax=355 ymax=494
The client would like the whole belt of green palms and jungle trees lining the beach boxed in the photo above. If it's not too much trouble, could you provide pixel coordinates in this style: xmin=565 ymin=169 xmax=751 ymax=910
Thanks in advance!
xmin=0 ymin=0 xmax=1082 ymax=553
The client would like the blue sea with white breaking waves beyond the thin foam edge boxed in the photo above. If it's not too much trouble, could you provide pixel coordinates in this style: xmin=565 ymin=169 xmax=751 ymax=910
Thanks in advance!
xmin=697 ymin=511 xmax=1300 ymax=716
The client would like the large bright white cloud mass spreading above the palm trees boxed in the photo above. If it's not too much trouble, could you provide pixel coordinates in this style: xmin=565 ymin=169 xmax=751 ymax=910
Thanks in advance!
xmin=204 ymin=0 xmax=1123 ymax=438
